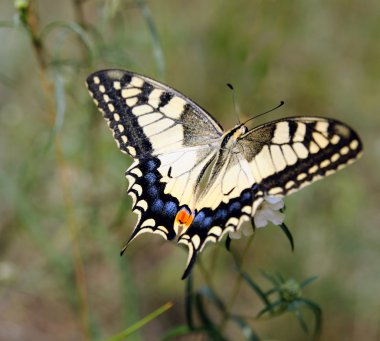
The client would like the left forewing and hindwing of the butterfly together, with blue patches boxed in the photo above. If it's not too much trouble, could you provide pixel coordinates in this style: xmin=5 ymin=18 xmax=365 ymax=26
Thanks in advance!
xmin=87 ymin=70 xmax=223 ymax=240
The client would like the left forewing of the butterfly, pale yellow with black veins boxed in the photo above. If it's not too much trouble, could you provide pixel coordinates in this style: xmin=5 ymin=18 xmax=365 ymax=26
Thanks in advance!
xmin=87 ymin=70 xmax=223 ymax=158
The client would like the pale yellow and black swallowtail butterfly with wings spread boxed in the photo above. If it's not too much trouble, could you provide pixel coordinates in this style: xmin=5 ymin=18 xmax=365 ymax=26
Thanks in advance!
xmin=87 ymin=70 xmax=362 ymax=278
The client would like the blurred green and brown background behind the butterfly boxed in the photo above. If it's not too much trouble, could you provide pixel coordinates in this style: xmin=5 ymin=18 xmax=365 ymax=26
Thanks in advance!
xmin=0 ymin=0 xmax=380 ymax=340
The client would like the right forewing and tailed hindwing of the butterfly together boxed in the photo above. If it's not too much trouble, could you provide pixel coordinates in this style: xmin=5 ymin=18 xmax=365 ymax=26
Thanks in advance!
xmin=179 ymin=117 xmax=362 ymax=277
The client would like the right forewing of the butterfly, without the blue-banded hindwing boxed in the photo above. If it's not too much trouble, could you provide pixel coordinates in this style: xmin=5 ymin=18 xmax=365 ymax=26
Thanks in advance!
xmin=238 ymin=117 xmax=362 ymax=196
